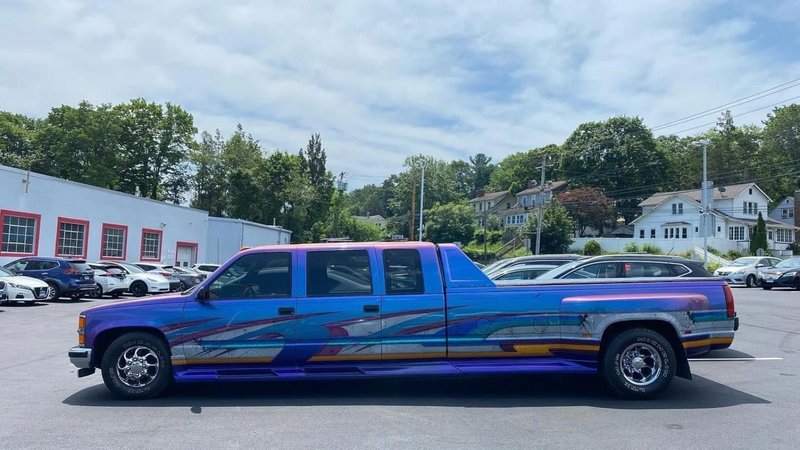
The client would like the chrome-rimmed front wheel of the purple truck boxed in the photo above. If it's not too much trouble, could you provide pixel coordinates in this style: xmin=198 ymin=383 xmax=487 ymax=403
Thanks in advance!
xmin=100 ymin=333 xmax=172 ymax=400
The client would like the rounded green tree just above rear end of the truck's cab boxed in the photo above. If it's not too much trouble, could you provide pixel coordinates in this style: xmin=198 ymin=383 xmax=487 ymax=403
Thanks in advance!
xmin=424 ymin=203 xmax=475 ymax=244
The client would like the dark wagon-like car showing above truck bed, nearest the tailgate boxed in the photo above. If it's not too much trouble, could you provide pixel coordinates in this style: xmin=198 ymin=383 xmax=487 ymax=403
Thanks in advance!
xmin=537 ymin=254 xmax=713 ymax=280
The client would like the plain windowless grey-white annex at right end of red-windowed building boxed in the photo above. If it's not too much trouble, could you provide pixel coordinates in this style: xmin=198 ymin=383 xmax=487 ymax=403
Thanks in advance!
xmin=203 ymin=217 xmax=292 ymax=264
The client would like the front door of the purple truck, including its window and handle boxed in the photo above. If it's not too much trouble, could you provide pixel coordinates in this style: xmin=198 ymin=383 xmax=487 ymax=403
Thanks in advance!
xmin=173 ymin=251 xmax=297 ymax=367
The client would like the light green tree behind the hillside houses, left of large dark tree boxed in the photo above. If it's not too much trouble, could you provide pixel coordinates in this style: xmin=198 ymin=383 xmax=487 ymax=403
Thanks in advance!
xmin=488 ymin=145 xmax=560 ymax=194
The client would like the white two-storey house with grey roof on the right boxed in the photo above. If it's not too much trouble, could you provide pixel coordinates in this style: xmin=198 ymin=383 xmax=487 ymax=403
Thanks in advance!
xmin=631 ymin=183 xmax=798 ymax=251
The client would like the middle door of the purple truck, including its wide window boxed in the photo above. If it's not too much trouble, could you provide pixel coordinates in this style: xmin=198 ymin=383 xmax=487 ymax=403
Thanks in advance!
xmin=292 ymin=246 xmax=381 ymax=363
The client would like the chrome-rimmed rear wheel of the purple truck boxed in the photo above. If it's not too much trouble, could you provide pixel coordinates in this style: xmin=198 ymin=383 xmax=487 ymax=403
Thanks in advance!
xmin=600 ymin=328 xmax=677 ymax=400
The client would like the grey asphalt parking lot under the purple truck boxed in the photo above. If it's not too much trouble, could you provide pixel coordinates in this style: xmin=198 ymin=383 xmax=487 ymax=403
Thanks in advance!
xmin=0 ymin=288 xmax=800 ymax=448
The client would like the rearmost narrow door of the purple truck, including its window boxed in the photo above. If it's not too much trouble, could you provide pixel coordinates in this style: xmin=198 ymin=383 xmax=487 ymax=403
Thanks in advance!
xmin=379 ymin=247 xmax=447 ymax=360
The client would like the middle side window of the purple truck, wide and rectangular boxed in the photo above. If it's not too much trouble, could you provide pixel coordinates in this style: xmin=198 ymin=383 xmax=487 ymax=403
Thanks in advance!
xmin=306 ymin=250 xmax=372 ymax=297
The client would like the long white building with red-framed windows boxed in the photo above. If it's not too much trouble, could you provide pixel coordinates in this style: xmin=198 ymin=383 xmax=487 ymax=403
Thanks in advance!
xmin=0 ymin=166 xmax=291 ymax=266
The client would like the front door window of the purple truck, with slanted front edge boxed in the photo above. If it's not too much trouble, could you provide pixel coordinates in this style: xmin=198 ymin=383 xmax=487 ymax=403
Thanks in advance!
xmin=208 ymin=252 xmax=292 ymax=299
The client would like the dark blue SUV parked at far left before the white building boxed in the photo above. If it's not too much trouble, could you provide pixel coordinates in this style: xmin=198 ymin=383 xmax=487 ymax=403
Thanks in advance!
xmin=5 ymin=256 xmax=96 ymax=300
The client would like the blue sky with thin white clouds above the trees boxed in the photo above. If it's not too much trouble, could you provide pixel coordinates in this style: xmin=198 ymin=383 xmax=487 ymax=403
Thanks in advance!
xmin=0 ymin=0 xmax=800 ymax=186
